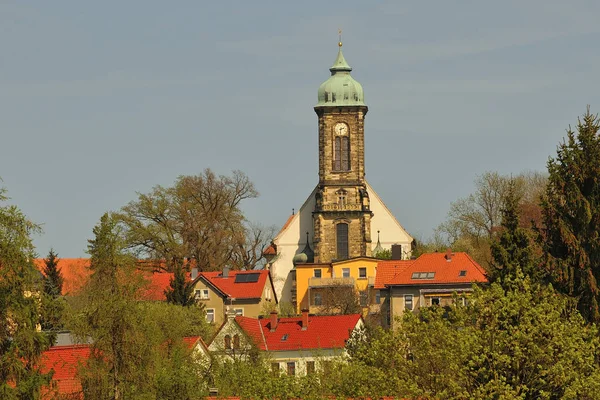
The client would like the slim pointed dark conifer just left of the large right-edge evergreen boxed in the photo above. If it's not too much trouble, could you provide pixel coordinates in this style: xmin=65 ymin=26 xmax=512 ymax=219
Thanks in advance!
xmin=489 ymin=179 xmax=539 ymax=283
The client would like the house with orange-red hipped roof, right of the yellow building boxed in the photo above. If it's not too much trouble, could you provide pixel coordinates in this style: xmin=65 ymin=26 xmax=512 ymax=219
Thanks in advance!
xmin=374 ymin=250 xmax=488 ymax=328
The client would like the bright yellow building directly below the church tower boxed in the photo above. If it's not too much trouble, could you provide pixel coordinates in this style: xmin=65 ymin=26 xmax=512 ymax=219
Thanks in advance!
xmin=292 ymin=257 xmax=378 ymax=314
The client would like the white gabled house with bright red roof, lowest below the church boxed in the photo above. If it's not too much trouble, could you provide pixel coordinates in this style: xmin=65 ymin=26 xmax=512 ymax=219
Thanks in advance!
xmin=208 ymin=310 xmax=363 ymax=375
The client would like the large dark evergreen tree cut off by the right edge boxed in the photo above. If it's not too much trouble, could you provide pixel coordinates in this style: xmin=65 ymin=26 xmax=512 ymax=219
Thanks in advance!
xmin=539 ymin=107 xmax=600 ymax=322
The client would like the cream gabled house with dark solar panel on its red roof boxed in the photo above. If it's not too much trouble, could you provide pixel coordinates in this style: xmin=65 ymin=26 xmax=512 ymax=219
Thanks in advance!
xmin=193 ymin=268 xmax=277 ymax=325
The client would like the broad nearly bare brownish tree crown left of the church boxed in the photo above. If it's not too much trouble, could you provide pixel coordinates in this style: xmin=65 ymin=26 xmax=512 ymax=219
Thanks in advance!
xmin=117 ymin=169 xmax=271 ymax=271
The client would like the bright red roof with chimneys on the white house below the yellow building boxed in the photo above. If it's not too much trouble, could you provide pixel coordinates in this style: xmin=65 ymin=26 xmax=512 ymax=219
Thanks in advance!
xmin=235 ymin=314 xmax=361 ymax=351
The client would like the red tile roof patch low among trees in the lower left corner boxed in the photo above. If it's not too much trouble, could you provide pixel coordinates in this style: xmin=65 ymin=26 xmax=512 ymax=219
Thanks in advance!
xmin=41 ymin=345 xmax=90 ymax=397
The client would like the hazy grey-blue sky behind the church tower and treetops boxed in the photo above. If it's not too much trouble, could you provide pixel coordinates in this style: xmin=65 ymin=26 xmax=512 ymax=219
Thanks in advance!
xmin=0 ymin=0 xmax=600 ymax=258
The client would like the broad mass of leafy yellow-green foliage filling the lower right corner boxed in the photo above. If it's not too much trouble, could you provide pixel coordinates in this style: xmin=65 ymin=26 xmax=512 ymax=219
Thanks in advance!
xmin=339 ymin=268 xmax=600 ymax=399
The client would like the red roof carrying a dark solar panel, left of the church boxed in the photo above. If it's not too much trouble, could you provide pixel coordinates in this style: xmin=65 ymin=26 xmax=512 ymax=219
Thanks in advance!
xmin=198 ymin=270 xmax=269 ymax=299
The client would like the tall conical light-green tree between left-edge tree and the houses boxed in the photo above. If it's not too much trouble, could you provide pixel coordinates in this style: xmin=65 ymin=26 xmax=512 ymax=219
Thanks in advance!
xmin=74 ymin=214 xmax=152 ymax=400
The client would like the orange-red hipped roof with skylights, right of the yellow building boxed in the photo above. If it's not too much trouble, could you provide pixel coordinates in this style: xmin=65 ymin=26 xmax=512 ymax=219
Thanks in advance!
xmin=386 ymin=252 xmax=488 ymax=286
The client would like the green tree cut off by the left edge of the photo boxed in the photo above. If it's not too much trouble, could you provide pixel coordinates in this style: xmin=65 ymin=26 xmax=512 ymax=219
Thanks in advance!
xmin=0 ymin=188 xmax=51 ymax=399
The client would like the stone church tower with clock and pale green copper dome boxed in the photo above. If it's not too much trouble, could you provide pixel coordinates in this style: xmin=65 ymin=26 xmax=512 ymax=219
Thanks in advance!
xmin=313 ymin=41 xmax=373 ymax=263
